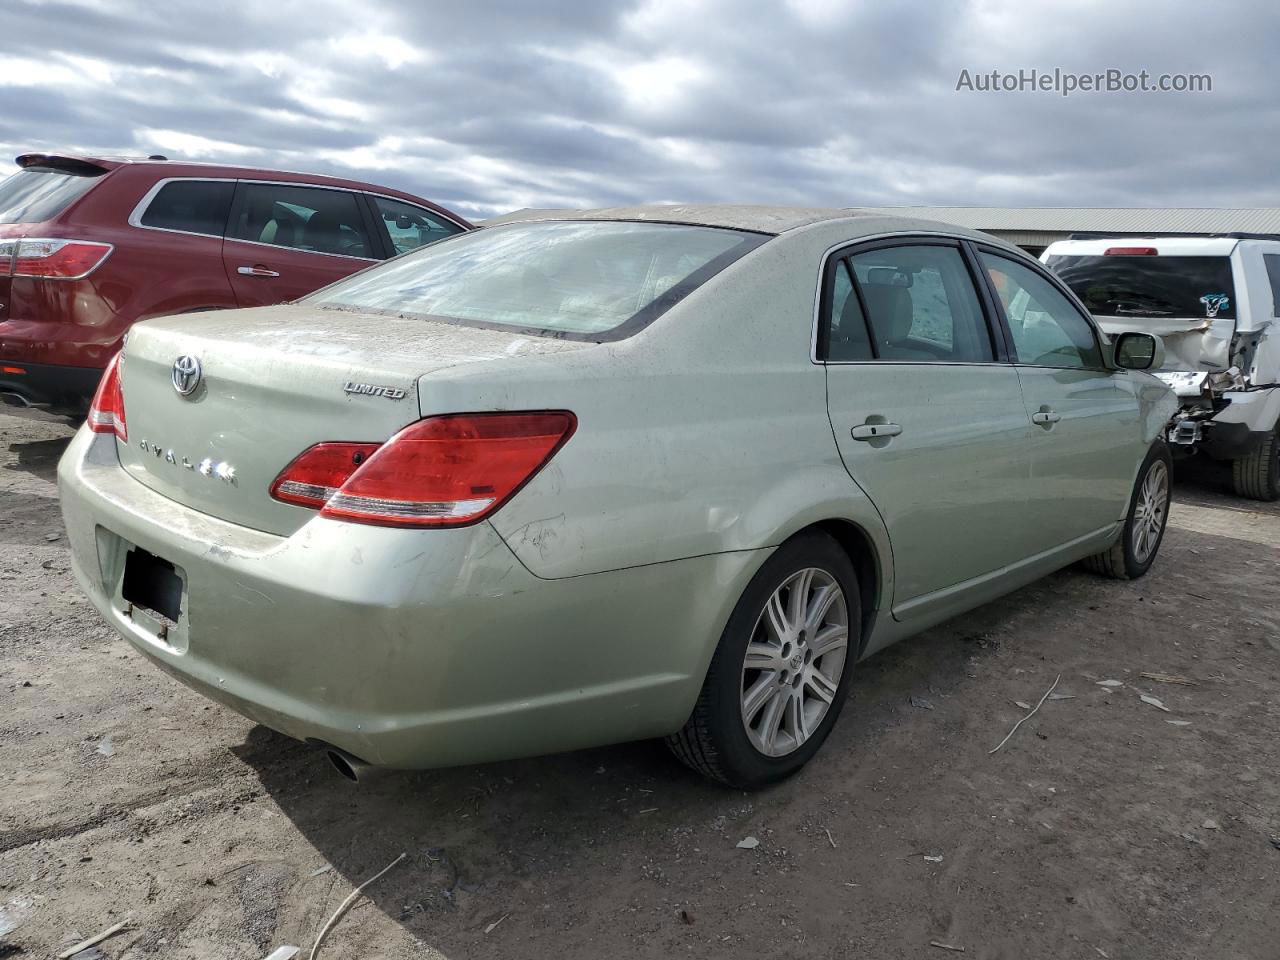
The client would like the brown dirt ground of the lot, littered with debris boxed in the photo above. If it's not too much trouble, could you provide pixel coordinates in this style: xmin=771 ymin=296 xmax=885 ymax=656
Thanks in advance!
xmin=0 ymin=413 xmax=1280 ymax=960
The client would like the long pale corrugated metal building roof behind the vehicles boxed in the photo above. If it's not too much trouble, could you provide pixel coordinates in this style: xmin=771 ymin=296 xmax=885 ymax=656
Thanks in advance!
xmin=860 ymin=206 xmax=1280 ymax=233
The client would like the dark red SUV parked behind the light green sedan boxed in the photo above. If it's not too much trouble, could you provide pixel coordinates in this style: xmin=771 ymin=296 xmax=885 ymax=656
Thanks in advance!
xmin=0 ymin=154 xmax=472 ymax=412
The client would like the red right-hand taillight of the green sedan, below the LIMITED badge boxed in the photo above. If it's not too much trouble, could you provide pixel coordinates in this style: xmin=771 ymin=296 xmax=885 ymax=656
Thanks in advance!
xmin=271 ymin=411 xmax=577 ymax=527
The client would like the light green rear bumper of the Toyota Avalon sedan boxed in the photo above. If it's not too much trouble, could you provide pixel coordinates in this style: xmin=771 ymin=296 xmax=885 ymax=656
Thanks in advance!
xmin=59 ymin=429 xmax=760 ymax=767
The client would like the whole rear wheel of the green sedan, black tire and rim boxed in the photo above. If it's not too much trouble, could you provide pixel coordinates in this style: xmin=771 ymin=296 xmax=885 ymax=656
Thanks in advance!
xmin=667 ymin=531 xmax=861 ymax=788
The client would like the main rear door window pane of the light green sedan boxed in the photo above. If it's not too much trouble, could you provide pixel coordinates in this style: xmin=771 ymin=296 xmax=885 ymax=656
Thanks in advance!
xmin=849 ymin=244 xmax=995 ymax=364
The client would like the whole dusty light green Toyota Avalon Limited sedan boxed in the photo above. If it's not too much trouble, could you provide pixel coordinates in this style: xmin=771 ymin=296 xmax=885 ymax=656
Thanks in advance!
xmin=59 ymin=206 xmax=1175 ymax=787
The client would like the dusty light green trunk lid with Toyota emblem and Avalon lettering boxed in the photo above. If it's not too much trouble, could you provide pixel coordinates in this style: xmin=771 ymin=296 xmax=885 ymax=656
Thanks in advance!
xmin=119 ymin=305 xmax=591 ymax=535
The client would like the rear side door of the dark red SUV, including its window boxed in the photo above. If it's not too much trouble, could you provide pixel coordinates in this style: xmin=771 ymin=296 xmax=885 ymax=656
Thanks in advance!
xmin=223 ymin=180 xmax=384 ymax=307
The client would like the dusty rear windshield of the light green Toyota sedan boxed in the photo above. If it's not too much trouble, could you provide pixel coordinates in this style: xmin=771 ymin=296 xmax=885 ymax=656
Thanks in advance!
xmin=306 ymin=220 xmax=768 ymax=340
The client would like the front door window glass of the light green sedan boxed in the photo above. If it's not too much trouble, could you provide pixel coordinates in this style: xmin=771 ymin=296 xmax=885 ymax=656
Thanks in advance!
xmin=979 ymin=252 xmax=1102 ymax=369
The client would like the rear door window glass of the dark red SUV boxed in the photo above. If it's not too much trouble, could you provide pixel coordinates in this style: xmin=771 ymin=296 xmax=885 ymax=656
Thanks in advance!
xmin=227 ymin=183 xmax=375 ymax=260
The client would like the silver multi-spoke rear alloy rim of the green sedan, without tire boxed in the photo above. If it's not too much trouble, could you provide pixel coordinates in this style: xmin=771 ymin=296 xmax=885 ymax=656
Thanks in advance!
xmin=740 ymin=567 xmax=849 ymax=756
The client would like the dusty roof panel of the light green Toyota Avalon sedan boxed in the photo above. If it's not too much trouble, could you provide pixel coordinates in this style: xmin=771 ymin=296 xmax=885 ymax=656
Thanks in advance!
xmin=483 ymin=204 xmax=1009 ymax=239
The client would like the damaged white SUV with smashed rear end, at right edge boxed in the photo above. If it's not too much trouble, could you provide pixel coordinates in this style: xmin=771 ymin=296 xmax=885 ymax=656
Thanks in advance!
xmin=1042 ymin=234 xmax=1280 ymax=500
